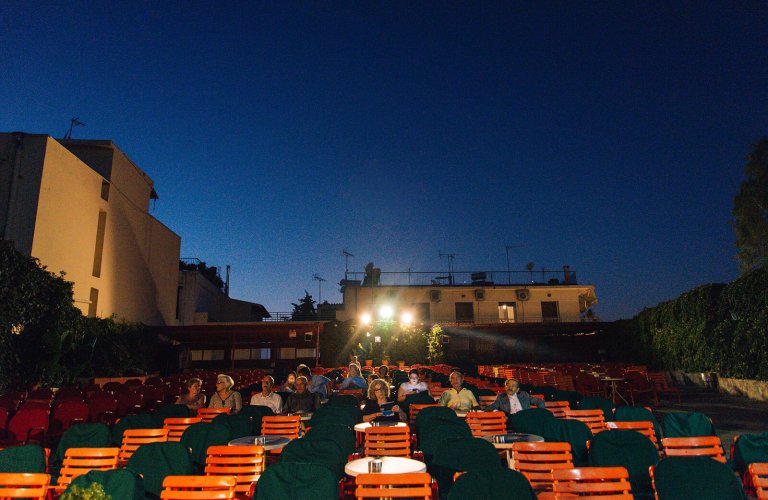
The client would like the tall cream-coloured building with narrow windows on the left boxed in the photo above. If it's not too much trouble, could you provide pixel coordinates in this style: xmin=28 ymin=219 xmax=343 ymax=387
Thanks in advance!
xmin=0 ymin=133 xmax=181 ymax=325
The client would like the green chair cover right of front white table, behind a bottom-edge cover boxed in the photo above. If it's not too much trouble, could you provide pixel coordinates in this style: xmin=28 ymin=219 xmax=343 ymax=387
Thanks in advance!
xmin=427 ymin=437 xmax=501 ymax=498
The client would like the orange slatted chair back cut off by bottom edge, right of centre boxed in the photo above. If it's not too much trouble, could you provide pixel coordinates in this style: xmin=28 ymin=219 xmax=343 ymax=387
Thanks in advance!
xmin=552 ymin=467 xmax=633 ymax=500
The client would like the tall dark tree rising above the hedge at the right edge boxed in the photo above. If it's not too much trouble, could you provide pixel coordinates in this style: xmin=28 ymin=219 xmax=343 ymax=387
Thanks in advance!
xmin=731 ymin=137 xmax=768 ymax=273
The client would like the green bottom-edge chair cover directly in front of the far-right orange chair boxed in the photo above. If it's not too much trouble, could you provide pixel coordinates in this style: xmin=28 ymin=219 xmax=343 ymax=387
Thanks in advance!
xmin=653 ymin=457 xmax=746 ymax=500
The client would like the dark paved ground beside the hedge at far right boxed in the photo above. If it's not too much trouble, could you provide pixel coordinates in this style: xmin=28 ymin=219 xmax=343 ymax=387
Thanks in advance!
xmin=653 ymin=387 xmax=768 ymax=446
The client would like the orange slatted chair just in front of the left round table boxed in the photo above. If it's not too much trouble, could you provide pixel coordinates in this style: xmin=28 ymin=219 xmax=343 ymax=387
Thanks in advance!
xmin=205 ymin=445 xmax=265 ymax=498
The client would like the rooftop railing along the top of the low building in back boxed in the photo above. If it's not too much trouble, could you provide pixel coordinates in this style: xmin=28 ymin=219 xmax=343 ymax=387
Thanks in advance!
xmin=342 ymin=269 xmax=577 ymax=286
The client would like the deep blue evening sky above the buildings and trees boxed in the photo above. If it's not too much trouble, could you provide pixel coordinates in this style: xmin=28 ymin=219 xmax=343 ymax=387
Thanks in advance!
xmin=0 ymin=0 xmax=768 ymax=319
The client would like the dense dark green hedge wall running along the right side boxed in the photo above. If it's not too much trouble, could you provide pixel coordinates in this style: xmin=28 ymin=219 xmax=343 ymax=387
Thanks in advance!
xmin=611 ymin=267 xmax=768 ymax=380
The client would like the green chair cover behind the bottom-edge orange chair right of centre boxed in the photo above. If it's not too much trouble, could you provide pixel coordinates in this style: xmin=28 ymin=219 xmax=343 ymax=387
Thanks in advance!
xmin=589 ymin=430 xmax=659 ymax=498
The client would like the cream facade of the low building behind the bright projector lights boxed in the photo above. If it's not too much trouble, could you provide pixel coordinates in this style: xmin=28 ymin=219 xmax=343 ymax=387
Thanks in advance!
xmin=336 ymin=284 xmax=597 ymax=324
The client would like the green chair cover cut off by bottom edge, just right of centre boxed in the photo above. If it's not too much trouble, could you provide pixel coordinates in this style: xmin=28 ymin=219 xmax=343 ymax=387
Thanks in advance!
xmin=448 ymin=468 xmax=537 ymax=500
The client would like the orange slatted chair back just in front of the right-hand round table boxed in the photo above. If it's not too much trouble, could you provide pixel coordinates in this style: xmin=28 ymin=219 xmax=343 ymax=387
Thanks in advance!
xmin=510 ymin=443 xmax=573 ymax=492
